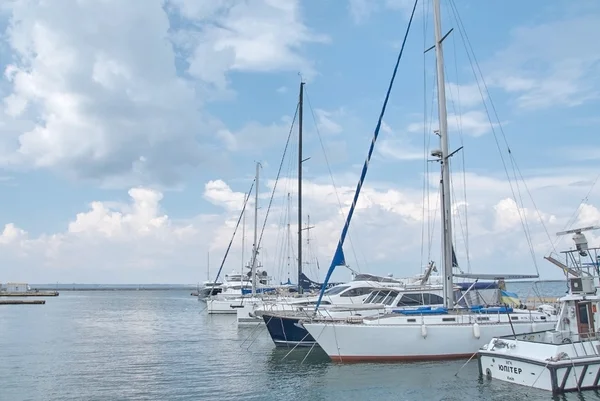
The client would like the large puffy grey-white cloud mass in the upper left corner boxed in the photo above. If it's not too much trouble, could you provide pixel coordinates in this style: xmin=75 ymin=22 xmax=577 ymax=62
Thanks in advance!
xmin=3 ymin=0 xmax=207 ymax=183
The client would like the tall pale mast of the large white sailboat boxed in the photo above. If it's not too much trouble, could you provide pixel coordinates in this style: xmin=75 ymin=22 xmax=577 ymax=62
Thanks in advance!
xmin=433 ymin=0 xmax=454 ymax=308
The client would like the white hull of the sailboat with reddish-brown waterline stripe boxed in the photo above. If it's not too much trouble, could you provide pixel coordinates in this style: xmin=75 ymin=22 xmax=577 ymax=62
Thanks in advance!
xmin=304 ymin=313 xmax=556 ymax=362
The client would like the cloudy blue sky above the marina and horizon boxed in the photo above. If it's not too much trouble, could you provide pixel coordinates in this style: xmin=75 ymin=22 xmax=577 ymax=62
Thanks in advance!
xmin=0 ymin=0 xmax=600 ymax=283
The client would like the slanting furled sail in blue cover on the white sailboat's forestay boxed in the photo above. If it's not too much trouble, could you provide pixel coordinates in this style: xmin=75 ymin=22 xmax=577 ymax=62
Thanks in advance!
xmin=315 ymin=0 xmax=418 ymax=313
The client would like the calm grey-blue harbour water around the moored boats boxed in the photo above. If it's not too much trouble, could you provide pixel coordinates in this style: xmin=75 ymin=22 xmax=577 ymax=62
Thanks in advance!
xmin=0 ymin=283 xmax=600 ymax=401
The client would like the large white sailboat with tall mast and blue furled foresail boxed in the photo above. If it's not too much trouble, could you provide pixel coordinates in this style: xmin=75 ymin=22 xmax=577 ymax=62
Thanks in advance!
xmin=299 ymin=0 xmax=557 ymax=362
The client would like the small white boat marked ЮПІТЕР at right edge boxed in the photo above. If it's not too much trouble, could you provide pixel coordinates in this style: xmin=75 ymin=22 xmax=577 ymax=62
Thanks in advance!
xmin=477 ymin=226 xmax=600 ymax=394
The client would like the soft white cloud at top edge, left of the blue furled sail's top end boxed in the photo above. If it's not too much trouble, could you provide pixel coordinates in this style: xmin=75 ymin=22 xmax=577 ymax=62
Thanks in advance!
xmin=172 ymin=0 xmax=329 ymax=90
